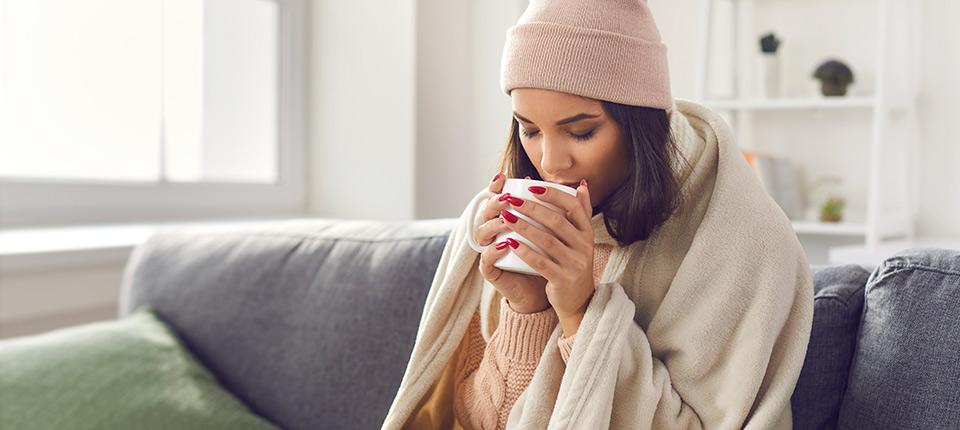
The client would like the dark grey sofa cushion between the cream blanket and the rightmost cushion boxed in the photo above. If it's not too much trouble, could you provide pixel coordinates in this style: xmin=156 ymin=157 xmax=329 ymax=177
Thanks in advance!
xmin=791 ymin=264 xmax=870 ymax=429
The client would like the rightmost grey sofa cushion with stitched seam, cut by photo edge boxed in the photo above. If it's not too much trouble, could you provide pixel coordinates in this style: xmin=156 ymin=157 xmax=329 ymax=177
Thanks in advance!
xmin=838 ymin=249 xmax=960 ymax=429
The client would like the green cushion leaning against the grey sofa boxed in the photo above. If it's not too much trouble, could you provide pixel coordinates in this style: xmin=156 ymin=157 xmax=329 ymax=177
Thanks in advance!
xmin=0 ymin=308 xmax=276 ymax=429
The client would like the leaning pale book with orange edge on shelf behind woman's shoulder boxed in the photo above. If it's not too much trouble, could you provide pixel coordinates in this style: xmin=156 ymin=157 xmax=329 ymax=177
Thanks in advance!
xmin=743 ymin=151 xmax=803 ymax=220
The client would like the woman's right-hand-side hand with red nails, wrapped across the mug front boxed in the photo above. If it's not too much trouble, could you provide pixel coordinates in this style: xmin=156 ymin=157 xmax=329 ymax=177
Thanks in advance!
xmin=501 ymin=181 xmax=596 ymax=336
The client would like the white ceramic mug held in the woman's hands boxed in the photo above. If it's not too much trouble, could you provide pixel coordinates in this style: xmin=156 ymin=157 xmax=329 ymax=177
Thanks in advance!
xmin=467 ymin=178 xmax=577 ymax=275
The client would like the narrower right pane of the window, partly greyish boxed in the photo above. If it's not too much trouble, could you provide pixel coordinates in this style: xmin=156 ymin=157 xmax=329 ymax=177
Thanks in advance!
xmin=164 ymin=0 xmax=279 ymax=182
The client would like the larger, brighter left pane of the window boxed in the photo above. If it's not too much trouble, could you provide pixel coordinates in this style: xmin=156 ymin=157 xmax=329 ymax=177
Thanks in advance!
xmin=0 ymin=0 xmax=161 ymax=181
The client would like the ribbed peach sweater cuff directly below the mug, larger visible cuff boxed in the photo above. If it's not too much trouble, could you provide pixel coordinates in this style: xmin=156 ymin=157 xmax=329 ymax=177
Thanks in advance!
xmin=491 ymin=297 xmax=559 ymax=362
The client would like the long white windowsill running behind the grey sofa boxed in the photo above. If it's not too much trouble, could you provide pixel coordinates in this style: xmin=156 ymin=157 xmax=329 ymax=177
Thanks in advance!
xmin=0 ymin=217 xmax=304 ymax=275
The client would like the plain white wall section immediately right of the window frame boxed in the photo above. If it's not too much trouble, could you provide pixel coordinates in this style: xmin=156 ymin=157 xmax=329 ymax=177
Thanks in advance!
xmin=307 ymin=0 xmax=417 ymax=219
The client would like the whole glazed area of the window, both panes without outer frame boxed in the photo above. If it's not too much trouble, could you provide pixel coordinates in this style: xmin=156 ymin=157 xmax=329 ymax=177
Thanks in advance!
xmin=0 ymin=0 xmax=279 ymax=183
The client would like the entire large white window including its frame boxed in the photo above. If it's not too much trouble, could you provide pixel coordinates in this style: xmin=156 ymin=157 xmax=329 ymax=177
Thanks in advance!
xmin=0 ymin=0 xmax=304 ymax=227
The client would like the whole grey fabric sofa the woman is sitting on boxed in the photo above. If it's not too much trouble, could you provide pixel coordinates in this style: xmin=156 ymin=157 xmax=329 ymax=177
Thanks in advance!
xmin=119 ymin=218 xmax=960 ymax=429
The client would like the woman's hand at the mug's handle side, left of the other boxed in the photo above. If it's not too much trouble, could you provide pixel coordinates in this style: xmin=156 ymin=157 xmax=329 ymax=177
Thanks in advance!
xmin=476 ymin=173 xmax=550 ymax=314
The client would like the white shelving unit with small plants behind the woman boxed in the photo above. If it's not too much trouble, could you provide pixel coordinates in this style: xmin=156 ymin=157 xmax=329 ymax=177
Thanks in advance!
xmin=694 ymin=0 xmax=923 ymax=249
